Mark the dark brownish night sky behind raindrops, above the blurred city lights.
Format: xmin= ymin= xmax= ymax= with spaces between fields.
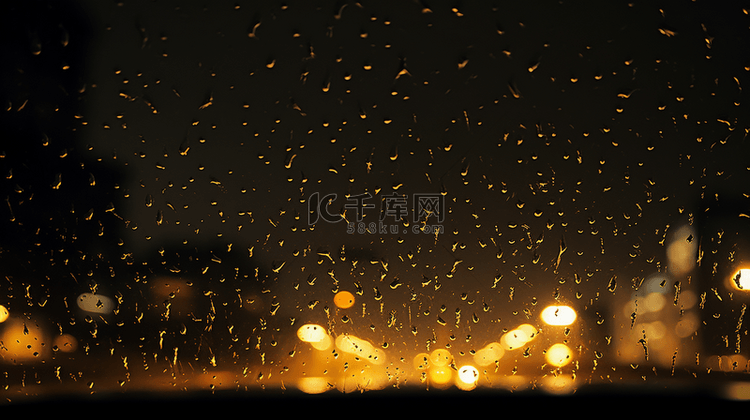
xmin=72 ymin=2 xmax=747 ymax=298
